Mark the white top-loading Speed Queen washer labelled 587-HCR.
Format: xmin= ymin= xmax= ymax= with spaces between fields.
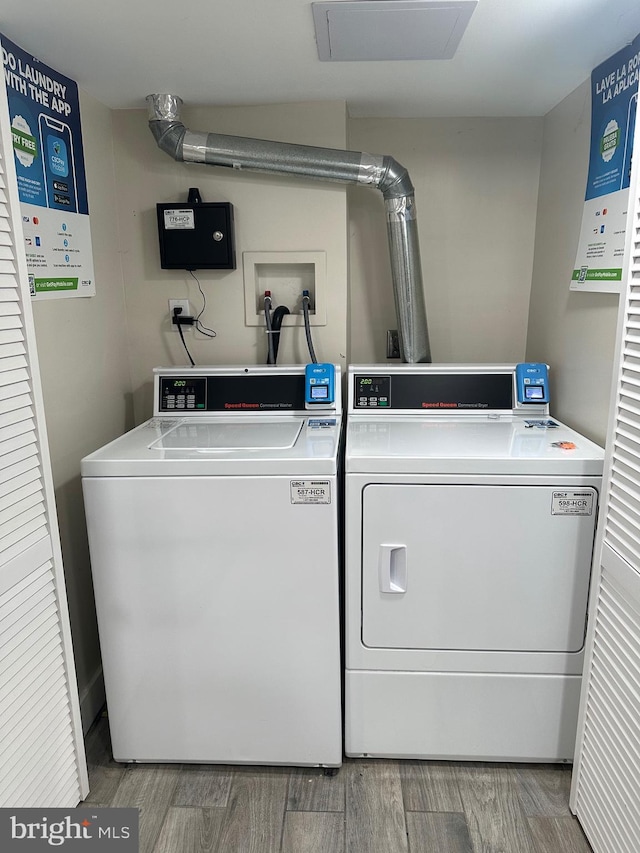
xmin=82 ymin=366 xmax=342 ymax=767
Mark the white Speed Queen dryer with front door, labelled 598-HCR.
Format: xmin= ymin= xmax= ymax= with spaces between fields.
xmin=345 ymin=365 xmax=603 ymax=761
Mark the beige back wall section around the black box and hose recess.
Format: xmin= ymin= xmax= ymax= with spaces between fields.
xmin=113 ymin=102 xmax=347 ymax=421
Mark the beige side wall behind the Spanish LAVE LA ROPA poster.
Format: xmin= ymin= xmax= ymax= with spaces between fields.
xmin=527 ymin=81 xmax=618 ymax=444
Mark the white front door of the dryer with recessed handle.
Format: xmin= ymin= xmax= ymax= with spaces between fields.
xmin=362 ymin=484 xmax=597 ymax=652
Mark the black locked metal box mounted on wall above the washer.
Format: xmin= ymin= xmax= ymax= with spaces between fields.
xmin=156 ymin=202 xmax=236 ymax=270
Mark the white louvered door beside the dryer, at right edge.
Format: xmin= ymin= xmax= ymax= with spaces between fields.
xmin=571 ymin=103 xmax=640 ymax=853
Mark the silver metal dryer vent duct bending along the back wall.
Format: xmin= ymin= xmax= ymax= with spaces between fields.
xmin=147 ymin=95 xmax=431 ymax=363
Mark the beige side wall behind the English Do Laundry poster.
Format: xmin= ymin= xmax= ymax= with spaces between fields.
xmin=33 ymin=88 xmax=132 ymax=725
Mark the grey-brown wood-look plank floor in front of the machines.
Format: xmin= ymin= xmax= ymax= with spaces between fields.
xmin=84 ymin=717 xmax=591 ymax=853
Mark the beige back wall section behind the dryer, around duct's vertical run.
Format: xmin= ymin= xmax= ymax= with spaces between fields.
xmin=349 ymin=118 xmax=542 ymax=363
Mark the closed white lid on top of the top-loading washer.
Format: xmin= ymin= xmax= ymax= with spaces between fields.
xmin=149 ymin=418 xmax=304 ymax=453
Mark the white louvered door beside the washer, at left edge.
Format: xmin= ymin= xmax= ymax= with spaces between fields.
xmin=0 ymin=70 xmax=88 ymax=808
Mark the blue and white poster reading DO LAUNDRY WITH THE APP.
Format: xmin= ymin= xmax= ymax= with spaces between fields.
xmin=0 ymin=35 xmax=96 ymax=299
